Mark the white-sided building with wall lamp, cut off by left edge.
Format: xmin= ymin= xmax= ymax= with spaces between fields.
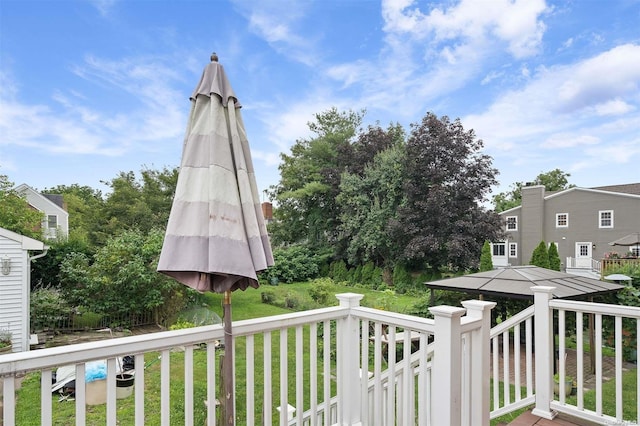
xmin=0 ymin=228 xmax=48 ymax=352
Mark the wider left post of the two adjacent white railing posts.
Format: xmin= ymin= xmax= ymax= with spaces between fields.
xmin=429 ymin=306 xmax=466 ymax=426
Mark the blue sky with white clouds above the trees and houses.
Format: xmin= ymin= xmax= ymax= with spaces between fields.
xmin=0 ymin=0 xmax=640 ymax=201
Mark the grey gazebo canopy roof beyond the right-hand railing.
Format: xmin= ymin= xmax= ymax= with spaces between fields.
xmin=426 ymin=265 xmax=624 ymax=299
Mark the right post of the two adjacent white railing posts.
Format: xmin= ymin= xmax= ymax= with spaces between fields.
xmin=462 ymin=300 xmax=496 ymax=426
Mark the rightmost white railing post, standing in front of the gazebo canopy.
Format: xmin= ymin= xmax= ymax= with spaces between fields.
xmin=531 ymin=286 xmax=557 ymax=420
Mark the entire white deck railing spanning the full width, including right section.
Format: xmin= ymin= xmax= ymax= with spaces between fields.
xmin=0 ymin=292 xmax=640 ymax=426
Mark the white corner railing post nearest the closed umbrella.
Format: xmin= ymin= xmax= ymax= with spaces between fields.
xmin=336 ymin=293 xmax=364 ymax=425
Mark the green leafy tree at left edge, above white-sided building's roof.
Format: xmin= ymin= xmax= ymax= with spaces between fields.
xmin=0 ymin=174 xmax=44 ymax=240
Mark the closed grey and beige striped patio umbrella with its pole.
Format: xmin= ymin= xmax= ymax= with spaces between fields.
xmin=158 ymin=53 xmax=273 ymax=424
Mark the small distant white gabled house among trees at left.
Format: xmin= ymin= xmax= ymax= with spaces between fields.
xmin=15 ymin=183 xmax=69 ymax=239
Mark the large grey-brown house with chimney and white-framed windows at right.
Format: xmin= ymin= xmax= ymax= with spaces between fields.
xmin=492 ymin=183 xmax=640 ymax=272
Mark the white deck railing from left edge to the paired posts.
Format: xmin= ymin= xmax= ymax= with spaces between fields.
xmin=0 ymin=294 xmax=493 ymax=426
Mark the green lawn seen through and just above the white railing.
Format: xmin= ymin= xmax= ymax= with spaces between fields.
xmin=16 ymin=282 xmax=416 ymax=426
